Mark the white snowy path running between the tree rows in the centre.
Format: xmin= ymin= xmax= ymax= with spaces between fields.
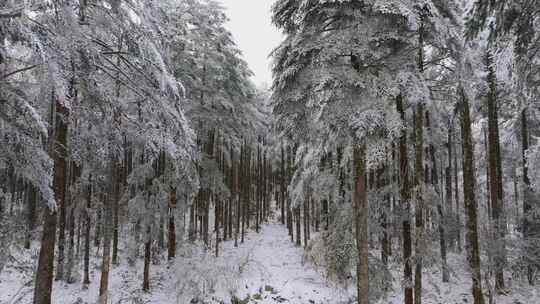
xmin=229 ymin=223 xmax=349 ymax=304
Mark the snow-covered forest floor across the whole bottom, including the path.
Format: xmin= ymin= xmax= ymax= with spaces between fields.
xmin=0 ymin=224 xmax=540 ymax=304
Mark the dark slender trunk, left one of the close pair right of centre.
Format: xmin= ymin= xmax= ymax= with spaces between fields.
xmin=396 ymin=95 xmax=413 ymax=304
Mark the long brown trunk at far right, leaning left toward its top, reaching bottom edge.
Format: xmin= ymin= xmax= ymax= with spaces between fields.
xmin=459 ymin=86 xmax=485 ymax=304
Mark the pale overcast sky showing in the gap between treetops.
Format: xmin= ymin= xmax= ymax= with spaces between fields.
xmin=219 ymin=0 xmax=282 ymax=85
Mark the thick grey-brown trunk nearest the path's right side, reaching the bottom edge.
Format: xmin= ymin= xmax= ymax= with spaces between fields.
xmin=353 ymin=143 xmax=369 ymax=304
